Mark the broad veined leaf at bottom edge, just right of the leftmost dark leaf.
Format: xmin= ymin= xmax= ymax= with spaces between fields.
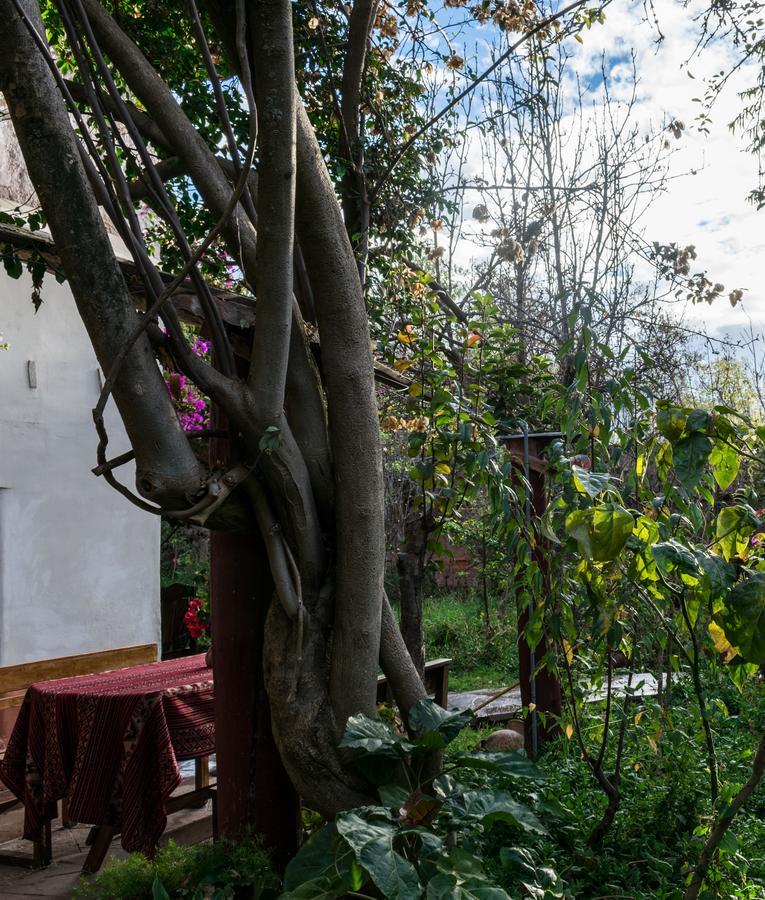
xmin=336 ymin=807 xmax=422 ymax=900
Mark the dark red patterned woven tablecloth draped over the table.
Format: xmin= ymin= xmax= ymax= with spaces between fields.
xmin=0 ymin=654 xmax=215 ymax=852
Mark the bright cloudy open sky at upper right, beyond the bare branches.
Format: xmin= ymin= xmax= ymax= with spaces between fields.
xmin=442 ymin=0 xmax=765 ymax=337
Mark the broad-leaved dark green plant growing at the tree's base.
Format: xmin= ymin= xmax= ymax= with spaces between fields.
xmin=282 ymin=700 xmax=545 ymax=900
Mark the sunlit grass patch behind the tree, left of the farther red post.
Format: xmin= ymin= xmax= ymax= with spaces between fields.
xmin=423 ymin=592 xmax=518 ymax=691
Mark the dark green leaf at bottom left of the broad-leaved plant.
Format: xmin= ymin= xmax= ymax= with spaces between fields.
xmin=284 ymin=822 xmax=361 ymax=900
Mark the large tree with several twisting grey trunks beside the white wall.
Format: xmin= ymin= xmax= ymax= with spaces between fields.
xmin=0 ymin=0 xmax=592 ymax=828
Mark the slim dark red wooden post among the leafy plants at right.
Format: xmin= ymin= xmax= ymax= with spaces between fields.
xmin=508 ymin=435 xmax=562 ymax=749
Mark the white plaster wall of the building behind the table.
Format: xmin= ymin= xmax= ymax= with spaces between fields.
xmin=0 ymin=268 xmax=160 ymax=665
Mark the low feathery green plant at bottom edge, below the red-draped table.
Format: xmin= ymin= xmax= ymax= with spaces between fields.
xmin=74 ymin=838 xmax=279 ymax=900
